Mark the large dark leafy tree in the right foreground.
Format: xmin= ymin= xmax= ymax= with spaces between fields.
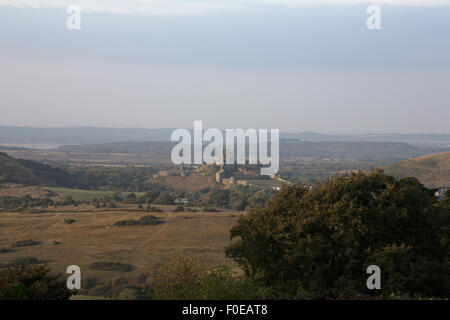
xmin=226 ymin=170 xmax=450 ymax=298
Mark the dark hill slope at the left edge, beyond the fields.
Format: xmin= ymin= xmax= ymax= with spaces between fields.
xmin=0 ymin=153 xmax=75 ymax=187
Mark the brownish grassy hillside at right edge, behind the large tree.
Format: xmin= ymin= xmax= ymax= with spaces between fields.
xmin=384 ymin=152 xmax=450 ymax=188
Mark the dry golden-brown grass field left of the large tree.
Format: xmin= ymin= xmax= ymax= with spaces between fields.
xmin=0 ymin=206 xmax=242 ymax=290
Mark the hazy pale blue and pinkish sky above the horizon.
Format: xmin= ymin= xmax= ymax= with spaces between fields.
xmin=0 ymin=0 xmax=450 ymax=133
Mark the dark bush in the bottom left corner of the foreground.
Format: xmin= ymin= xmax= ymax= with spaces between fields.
xmin=0 ymin=265 xmax=74 ymax=300
